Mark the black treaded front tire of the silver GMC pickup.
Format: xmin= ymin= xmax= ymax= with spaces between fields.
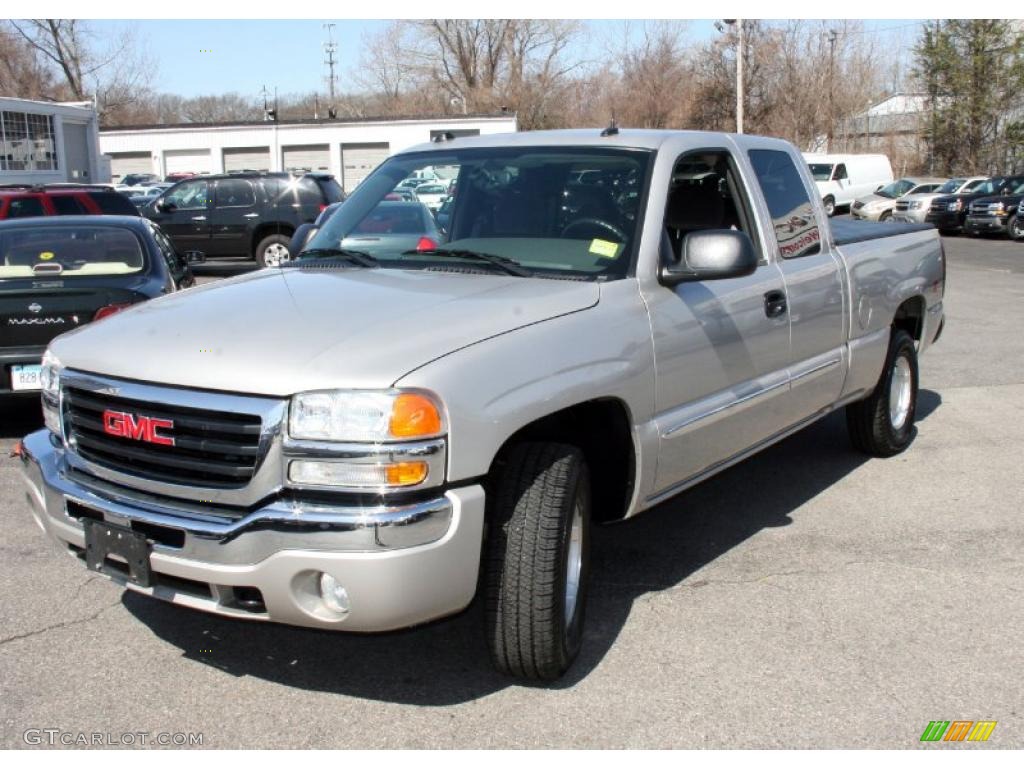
xmin=484 ymin=442 xmax=591 ymax=680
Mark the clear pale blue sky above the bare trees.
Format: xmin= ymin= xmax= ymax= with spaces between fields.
xmin=91 ymin=19 xmax=929 ymax=97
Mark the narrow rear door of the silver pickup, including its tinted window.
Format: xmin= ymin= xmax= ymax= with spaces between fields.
xmin=748 ymin=145 xmax=848 ymax=424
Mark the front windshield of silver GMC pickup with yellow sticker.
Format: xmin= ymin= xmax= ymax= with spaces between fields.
xmin=298 ymin=146 xmax=653 ymax=280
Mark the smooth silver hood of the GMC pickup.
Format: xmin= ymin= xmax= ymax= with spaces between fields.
xmin=50 ymin=267 xmax=600 ymax=396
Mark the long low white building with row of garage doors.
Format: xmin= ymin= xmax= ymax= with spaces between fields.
xmin=99 ymin=114 xmax=516 ymax=193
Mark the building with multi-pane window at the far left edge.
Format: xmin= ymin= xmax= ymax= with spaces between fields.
xmin=0 ymin=97 xmax=109 ymax=184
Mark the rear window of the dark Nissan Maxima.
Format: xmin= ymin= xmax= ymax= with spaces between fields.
xmin=0 ymin=226 xmax=144 ymax=279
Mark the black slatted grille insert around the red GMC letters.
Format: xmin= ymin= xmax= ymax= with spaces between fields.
xmin=62 ymin=386 xmax=262 ymax=488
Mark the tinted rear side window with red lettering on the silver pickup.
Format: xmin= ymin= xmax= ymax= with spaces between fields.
xmin=750 ymin=150 xmax=821 ymax=259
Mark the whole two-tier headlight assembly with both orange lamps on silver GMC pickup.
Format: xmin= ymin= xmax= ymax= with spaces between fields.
xmin=284 ymin=390 xmax=447 ymax=494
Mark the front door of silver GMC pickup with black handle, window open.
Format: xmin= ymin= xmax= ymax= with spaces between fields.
xmin=645 ymin=148 xmax=790 ymax=493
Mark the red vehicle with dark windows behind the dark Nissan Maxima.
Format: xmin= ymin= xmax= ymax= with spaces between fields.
xmin=0 ymin=184 xmax=138 ymax=220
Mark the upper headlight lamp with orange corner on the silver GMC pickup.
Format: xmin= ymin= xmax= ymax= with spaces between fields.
xmin=288 ymin=390 xmax=444 ymax=442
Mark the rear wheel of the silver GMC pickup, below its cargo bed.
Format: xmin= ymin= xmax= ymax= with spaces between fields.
xmin=846 ymin=329 xmax=918 ymax=457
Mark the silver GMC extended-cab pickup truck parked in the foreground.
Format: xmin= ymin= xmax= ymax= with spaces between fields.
xmin=16 ymin=128 xmax=945 ymax=680
